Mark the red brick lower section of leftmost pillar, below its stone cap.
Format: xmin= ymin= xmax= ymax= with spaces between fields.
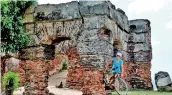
xmin=22 ymin=60 xmax=49 ymax=95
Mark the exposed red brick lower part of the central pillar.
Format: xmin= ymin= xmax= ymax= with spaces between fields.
xmin=66 ymin=48 xmax=106 ymax=95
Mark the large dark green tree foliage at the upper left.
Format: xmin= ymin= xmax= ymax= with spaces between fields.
xmin=0 ymin=0 xmax=37 ymax=53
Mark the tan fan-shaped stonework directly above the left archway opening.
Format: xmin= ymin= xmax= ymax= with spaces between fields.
xmin=35 ymin=20 xmax=82 ymax=44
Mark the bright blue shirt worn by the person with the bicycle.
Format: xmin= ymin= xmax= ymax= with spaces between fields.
xmin=112 ymin=57 xmax=123 ymax=73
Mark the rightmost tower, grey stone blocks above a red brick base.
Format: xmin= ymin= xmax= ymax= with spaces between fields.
xmin=125 ymin=19 xmax=152 ymax=89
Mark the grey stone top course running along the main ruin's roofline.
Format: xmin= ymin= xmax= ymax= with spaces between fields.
xmin=29 ymin=0 xmax=129 ymax=31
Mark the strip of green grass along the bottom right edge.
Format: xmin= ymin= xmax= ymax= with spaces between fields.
xmin=112 ymin=91 xmax=172 ymax=95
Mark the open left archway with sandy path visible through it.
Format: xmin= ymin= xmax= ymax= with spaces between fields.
xmin=48 ymin=35 xmax=72 ymax=87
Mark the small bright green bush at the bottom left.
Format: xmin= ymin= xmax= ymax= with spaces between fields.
xmin=2 ymin=72 xmax=19 ymax=95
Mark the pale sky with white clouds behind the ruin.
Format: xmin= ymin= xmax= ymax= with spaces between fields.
xmin=38 ymin=0 xmax=172 ymax=88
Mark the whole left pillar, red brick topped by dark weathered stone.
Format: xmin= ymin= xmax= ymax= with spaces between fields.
xmin=20 ymin=45 xmax=55 ymax=95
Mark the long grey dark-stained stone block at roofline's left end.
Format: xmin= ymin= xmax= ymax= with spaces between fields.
xmin=34 ymin=1 xmax=81 ymax=21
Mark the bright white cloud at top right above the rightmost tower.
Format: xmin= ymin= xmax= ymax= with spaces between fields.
xmin=128 ymin=0 xmax=166 ymax=14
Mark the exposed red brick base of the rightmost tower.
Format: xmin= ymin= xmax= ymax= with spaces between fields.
xmin=124 ymin=62 xmax=152 ymax=89
